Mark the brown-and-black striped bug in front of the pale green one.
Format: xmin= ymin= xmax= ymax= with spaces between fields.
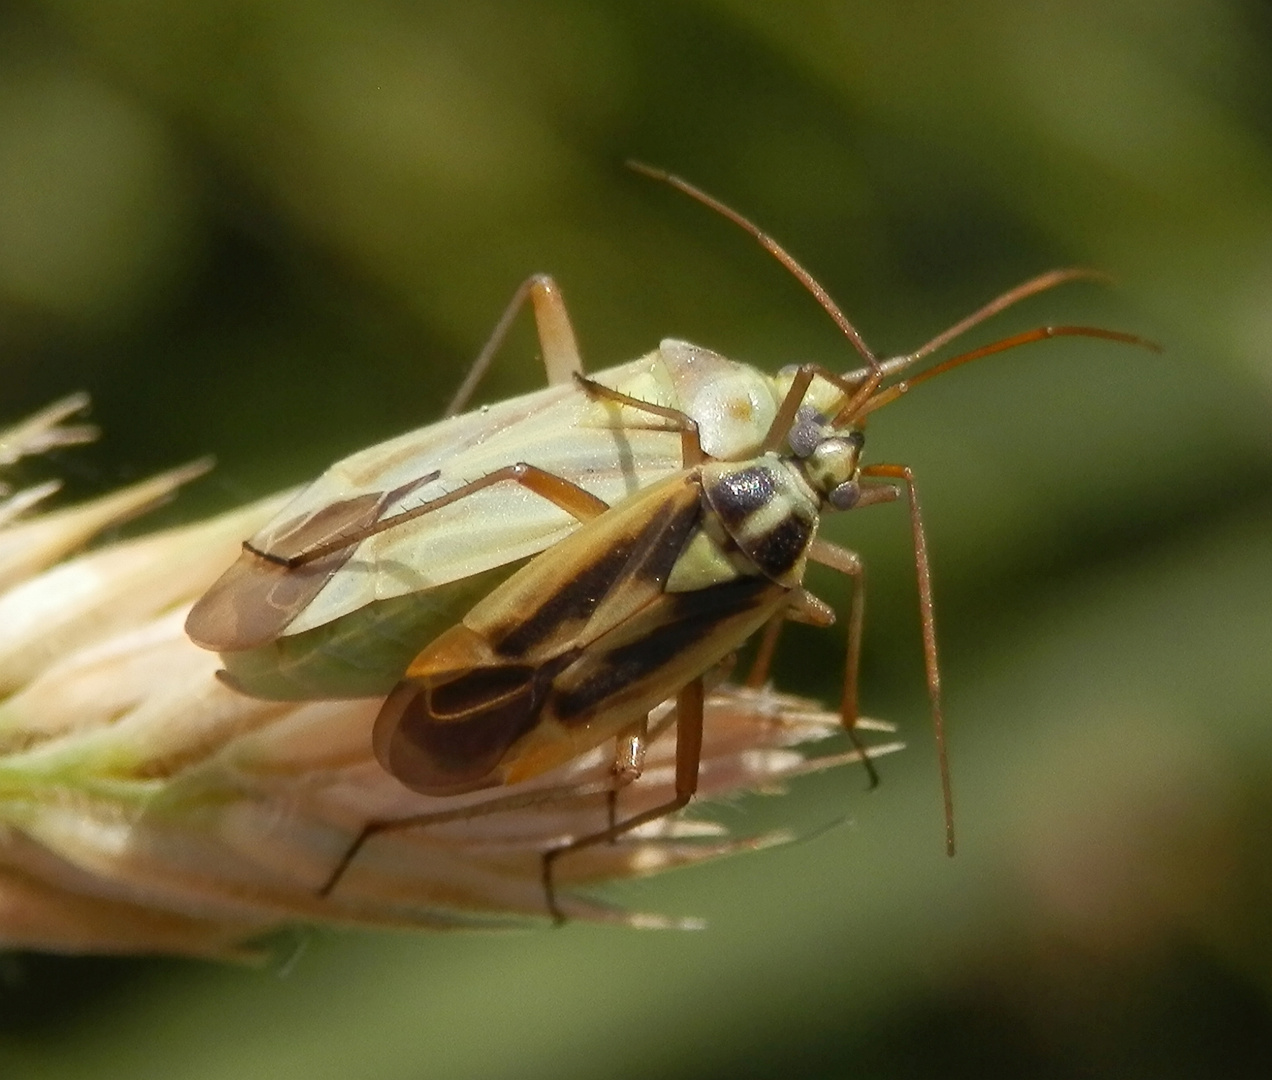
xmin=312 ymin=164 xmax=1147 ymax=921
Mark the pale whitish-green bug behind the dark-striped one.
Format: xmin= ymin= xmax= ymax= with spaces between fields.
xmin=186 ymin=286 xmax=803 ymax=698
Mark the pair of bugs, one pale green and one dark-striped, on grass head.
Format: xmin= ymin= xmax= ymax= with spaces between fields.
xmin=187 ymin=167 xmax=1147 ymax=920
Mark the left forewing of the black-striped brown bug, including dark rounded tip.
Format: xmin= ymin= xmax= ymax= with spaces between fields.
xmin=373 ymin=473 xmax=701 ymax=795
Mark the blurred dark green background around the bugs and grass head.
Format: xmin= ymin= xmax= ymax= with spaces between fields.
xmin=0 ymin=0 xmax=1272 ymax=1080
